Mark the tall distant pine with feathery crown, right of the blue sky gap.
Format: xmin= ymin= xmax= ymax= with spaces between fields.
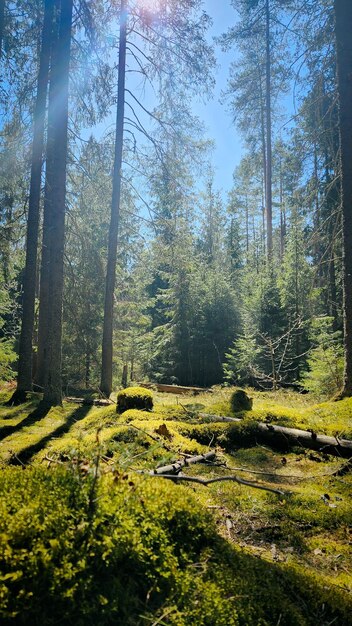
xmin=220 ymin=0 xmax=292 ymax=265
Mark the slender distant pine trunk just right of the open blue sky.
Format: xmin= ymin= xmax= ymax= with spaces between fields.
xmin=265 ymin=0 xmax=273 ymax=265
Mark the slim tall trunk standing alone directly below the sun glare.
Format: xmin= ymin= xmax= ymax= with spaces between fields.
xmin=100 ymin=0 xmax=127 ymax=396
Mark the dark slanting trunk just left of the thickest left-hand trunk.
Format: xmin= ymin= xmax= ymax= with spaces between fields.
xmin=14 ymin=0 xmax=54 ymax=401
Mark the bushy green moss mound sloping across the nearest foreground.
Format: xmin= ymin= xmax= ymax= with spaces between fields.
xmin=0 ymin=468 xmax=352 ymax=626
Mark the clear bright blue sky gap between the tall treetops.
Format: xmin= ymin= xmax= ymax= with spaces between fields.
xmin=193 ymin=0 xmax=242 ymax=197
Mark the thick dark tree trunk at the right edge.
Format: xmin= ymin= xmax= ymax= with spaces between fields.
xmin=334 ymin=0 xmax=352 ymax=396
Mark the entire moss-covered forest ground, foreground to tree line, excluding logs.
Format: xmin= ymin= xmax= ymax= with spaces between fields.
xmin=0 ymin=388 xmax=352 ymax=626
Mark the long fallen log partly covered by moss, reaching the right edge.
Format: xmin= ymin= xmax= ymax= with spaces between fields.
xmin=199 ymin=413 xmax=352 ymax=459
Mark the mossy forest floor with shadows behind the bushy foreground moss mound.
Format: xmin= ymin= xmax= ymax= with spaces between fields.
xmin=0 ymin=388 xmax=352 ymax=626
